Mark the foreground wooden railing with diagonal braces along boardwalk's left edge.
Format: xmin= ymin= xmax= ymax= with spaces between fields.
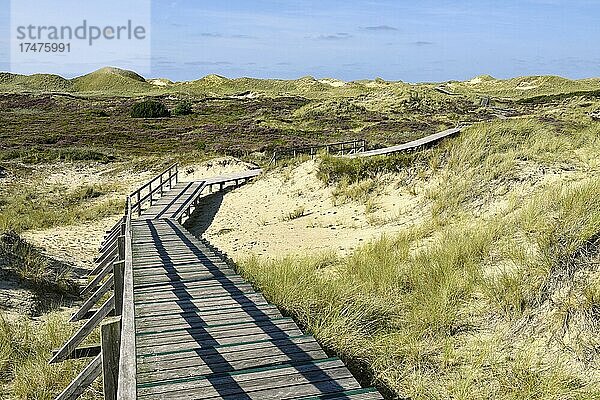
xmin=50 ymin=205 xmax=130 ymax=400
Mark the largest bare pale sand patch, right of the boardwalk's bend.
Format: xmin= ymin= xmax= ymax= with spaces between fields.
xmin=188 ymin=161 xmax=422 ymax=259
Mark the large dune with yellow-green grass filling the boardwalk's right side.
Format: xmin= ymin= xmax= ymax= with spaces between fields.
xmin=240 ymin=119 xmax=600 ymax=399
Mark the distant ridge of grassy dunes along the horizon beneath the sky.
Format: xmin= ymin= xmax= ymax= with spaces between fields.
xmin=0 ymin=67 xmax=600 ymax=100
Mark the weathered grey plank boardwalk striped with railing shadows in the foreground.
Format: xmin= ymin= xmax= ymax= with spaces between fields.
xmin=54 ymin=165 xmax=382 ymax=400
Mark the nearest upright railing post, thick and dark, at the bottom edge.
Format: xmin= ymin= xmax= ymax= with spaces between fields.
xmin=100 ymin=317 xmax=121 ymax=400
